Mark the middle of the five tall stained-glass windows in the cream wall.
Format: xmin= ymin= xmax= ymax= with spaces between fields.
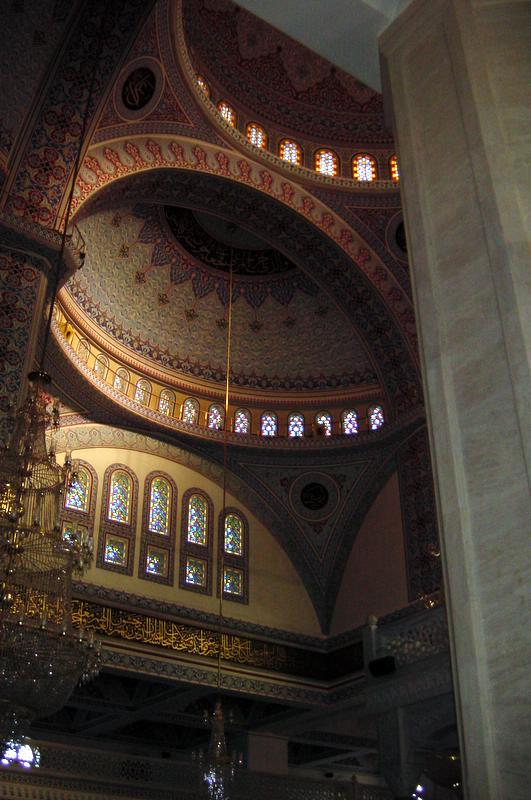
xmin=138 ymin=472 xmax=177 ymax=585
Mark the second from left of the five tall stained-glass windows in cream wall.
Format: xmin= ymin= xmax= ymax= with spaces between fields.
xmin=97 ymin=464 xmax=138 ymax=575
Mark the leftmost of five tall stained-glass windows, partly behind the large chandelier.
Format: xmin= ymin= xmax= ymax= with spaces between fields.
xmin=61 ymin=461 xmax=98 ymax=569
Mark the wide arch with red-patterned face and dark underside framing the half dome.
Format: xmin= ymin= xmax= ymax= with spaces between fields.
xmin=73 ymin=147 xmax=420 ymax=411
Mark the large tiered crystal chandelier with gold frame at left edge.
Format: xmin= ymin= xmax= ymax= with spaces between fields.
xmin=0 ymin=372 xmax=99 ymax=748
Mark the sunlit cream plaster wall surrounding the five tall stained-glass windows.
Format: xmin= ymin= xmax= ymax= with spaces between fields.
xmin=63 ymin=447 xmax=320 ymax=636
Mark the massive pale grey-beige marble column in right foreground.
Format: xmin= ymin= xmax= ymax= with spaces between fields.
xmin=380 ymin=0 xmax=531 ymax=800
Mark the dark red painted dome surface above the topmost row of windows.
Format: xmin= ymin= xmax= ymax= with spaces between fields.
xmin=183 ymin=0 xmax=392 ymax=145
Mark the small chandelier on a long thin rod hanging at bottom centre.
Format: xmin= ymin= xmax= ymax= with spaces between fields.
xmin=198 ymin=257 xmax=243 ymax=800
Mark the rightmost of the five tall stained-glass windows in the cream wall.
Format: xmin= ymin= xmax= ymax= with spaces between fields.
xmin=218 ymin=508 xmax=249 ymax=603
